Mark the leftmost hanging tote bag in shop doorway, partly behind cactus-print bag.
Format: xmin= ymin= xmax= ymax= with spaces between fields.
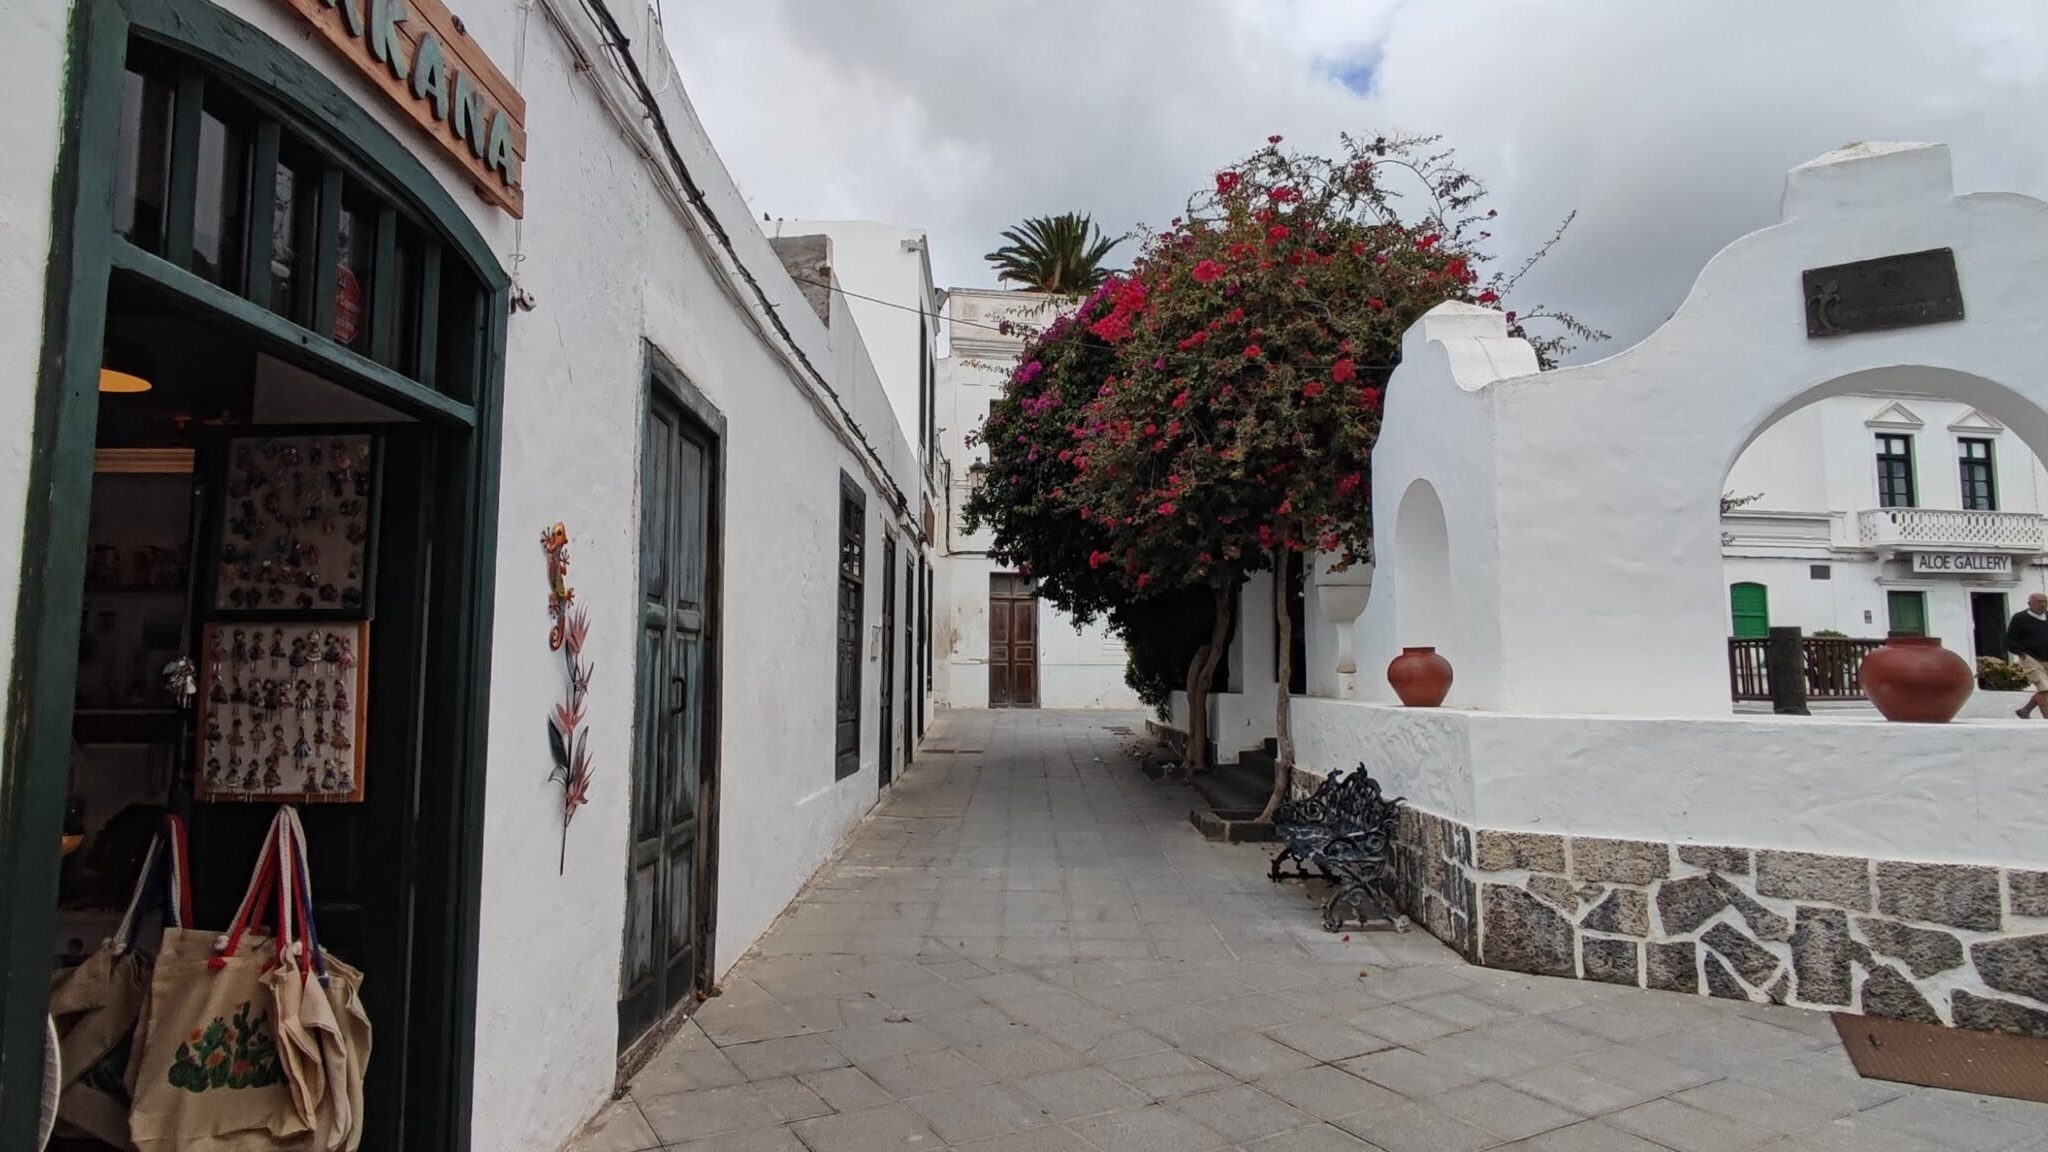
xmin=49 ymin=816 xmax=193 ymax=1150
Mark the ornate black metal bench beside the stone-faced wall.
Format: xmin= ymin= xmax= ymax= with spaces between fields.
xmin=1268 ymin=763 xmax=1407 ymax=933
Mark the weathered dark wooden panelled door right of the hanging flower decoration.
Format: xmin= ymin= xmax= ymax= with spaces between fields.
xmin=618 ymin=389 xmax=717 ymax=1052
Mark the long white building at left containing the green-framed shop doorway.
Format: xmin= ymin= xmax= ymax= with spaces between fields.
xmin=0 ymin=0 xmax=930 ymax=1152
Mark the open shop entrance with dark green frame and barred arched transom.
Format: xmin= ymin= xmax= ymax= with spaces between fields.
xmin=0 ymin=0 xmax=506 ymax=1150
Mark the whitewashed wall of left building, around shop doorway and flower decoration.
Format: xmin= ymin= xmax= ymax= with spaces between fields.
xmin=0 ymin=0 xmax=918 ymax=1152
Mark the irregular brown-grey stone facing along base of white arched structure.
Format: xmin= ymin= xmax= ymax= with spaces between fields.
xmin=1395 ymin=808 xmax=2048 ymax=1035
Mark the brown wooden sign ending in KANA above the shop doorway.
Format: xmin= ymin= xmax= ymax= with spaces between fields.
xmin=285 ymin=0 xmax=526 ymax=217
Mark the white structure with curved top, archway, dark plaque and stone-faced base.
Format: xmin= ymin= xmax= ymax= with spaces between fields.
xmin=1187 ymin=143 xmax=2048 ymax=1035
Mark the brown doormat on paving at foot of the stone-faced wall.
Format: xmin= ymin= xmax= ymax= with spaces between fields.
xmin=1833 ymin=1013 xmax=2048 ymax=1103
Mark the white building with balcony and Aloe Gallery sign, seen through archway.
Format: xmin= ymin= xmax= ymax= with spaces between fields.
xmin=1722 ymin=389 xmax=2048 ymax=658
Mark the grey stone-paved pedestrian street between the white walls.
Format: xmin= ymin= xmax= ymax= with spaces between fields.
xmin=573 ymin=711 xmax=2048 ymax=1152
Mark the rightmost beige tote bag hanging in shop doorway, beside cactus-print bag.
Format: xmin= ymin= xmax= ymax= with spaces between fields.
xmin=264 ymin=808 xmax=371 ymax=1152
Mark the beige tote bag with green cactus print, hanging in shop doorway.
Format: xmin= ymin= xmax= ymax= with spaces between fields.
xmin=129 ymin=814 xmax=311 ymax=1152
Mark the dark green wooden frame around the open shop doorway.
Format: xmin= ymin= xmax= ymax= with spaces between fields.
xmin=0 ymin=0 xmax=508 ymax=1150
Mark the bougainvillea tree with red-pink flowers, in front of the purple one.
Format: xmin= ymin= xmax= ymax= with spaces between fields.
xmin=1081 ymin=137 xmax=1597 ymax=816
